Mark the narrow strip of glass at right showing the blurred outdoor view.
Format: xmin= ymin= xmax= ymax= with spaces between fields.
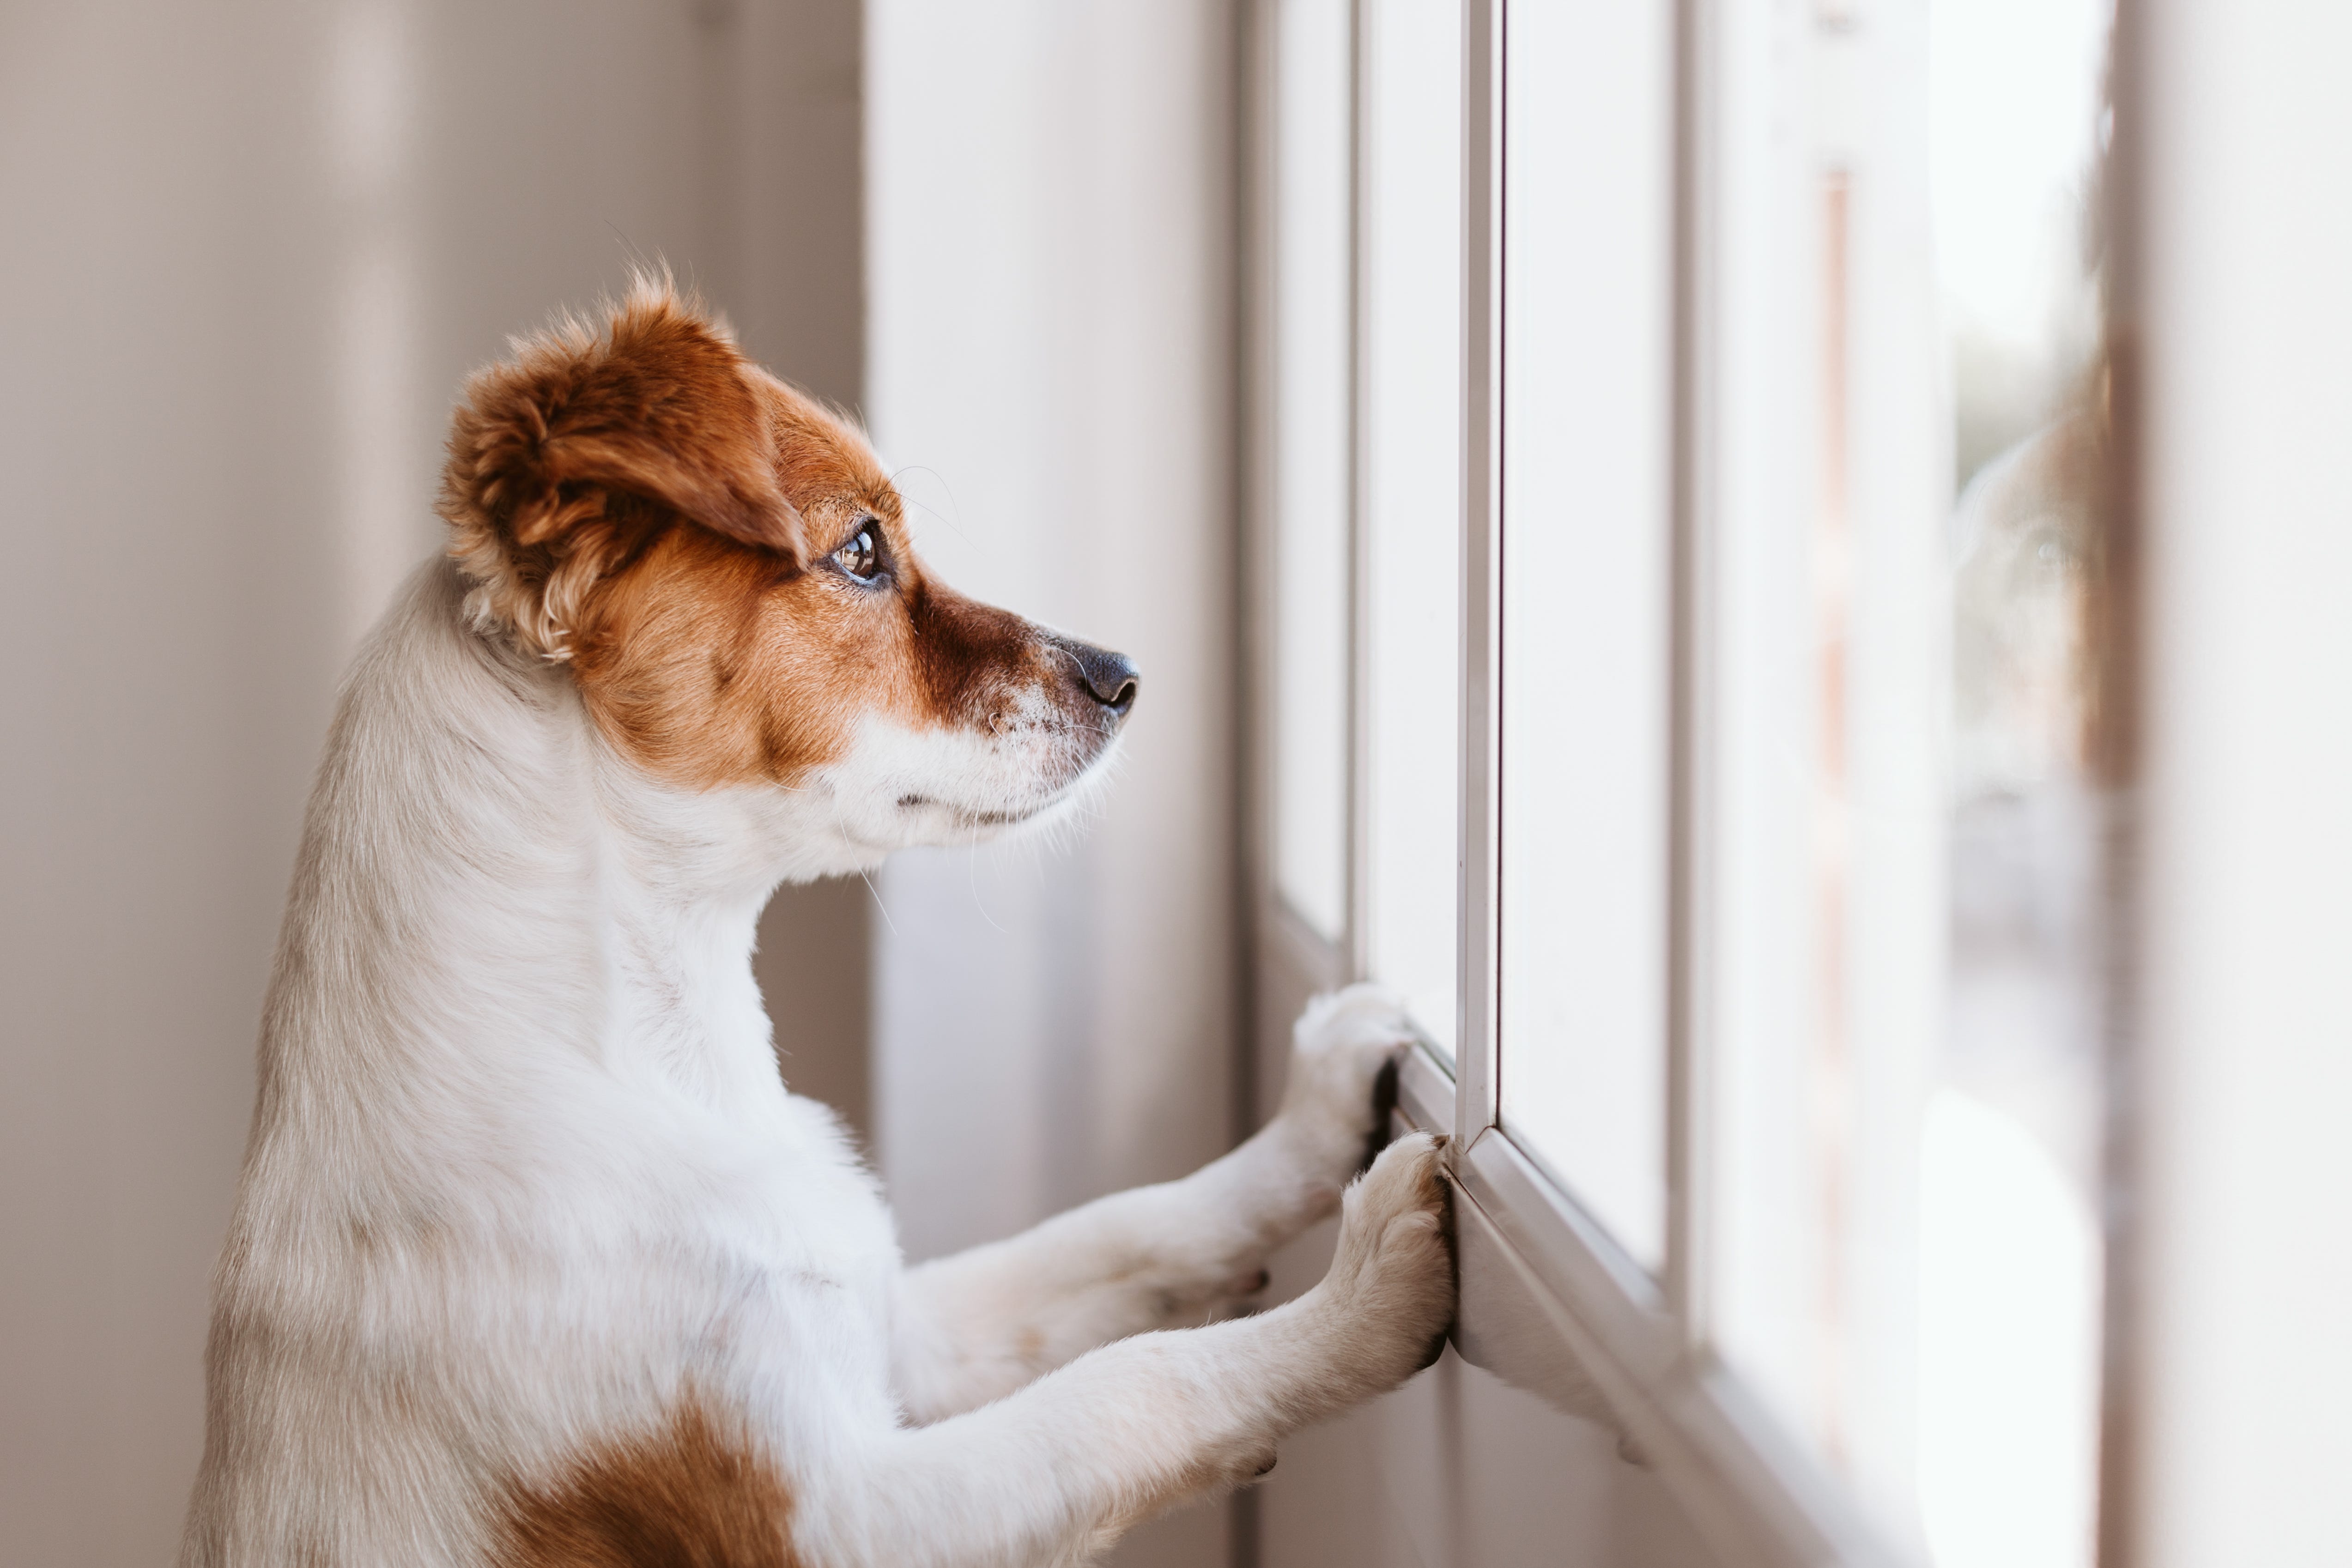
xmin=1919 ymin=0 xmax=2112 ymax=1568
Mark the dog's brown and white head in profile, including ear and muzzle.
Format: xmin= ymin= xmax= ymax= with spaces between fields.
xmin=442 ymin=282 xmax=1136 ymax=863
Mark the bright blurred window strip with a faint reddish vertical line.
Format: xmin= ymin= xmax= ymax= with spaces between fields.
xmin=1712 ymin=14 xmax=1950 ymax=1535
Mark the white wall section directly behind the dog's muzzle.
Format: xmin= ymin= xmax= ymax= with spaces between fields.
xmin=866 ymin=0 xmax=1239 ymax=1563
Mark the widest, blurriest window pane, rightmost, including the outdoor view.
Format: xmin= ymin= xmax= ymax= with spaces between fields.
xmin=1705 ymin=0 xmax=2107 ymax=1568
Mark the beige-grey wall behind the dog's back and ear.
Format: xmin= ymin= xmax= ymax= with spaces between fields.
xmin=0 ymin=0 xmax=863 ymax=1568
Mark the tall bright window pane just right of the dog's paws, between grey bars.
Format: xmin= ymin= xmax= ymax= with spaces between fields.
xmin=1498 ymin=0 xmax=1675 ymax=1267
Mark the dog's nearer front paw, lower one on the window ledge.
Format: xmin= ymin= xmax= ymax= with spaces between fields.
xmin=1308 ymin=1133 xmax=1454 ymax=1399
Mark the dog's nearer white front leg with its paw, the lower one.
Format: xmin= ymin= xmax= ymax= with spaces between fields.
xmin=813 ymin=1133 xmax=1454 ymax=1568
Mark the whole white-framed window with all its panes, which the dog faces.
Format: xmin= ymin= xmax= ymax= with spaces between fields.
xmin=1263 ymin=0 xmax=2110 ymax=1568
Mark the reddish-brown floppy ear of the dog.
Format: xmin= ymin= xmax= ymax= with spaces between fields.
xmin=440 ymin=278 xmax=807 ymax=658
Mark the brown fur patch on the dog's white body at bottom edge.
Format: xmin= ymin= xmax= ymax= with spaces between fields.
xmin=491 ymin=1396 xmax=795 ymax=1568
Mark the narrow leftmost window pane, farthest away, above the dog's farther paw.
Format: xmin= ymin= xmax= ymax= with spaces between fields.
xmin=1273 ymin=0 xmax=1352 ymax=940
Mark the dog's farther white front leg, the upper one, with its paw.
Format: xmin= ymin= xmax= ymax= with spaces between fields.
xmin=894 ymin=985 xmax=1409 ymax=1420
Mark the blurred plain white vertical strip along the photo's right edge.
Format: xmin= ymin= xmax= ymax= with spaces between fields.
xmin=2124 ymin=0 xmax=2352 ymax=1568
